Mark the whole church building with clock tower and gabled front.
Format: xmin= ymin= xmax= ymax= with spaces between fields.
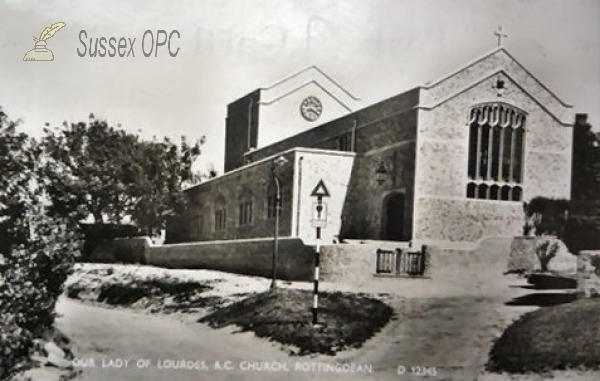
xmin=167 ymin=47 xmax=574 ymax=245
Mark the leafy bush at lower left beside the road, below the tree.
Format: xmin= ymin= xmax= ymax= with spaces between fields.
xmin=0 ymin=212 xmax=79 ymax=377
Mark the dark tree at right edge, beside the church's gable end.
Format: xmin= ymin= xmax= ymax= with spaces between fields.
xmin=571 ymin=114 xmax=600 ymax=200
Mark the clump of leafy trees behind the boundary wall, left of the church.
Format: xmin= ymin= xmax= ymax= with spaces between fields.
xmin=43 ymin=115 xmax=204 ymax=235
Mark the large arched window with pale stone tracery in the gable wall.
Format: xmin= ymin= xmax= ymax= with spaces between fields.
xmin=466 ymin=103 xmax=525 ymax=201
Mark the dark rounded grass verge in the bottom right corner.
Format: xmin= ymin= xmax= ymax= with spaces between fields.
xmin=486 ymin=299 xmax=600 ymax=373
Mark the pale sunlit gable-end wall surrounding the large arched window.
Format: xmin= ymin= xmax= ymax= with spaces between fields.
xmin=414 ymin=50 xmax=572 ymax=242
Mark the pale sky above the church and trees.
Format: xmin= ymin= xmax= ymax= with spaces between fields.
xmin=0 ymin=0 xmax=600 ymax=173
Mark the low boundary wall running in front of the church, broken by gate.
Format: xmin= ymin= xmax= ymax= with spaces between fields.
xmin=79 ymin=237 xmax=536 ymax=284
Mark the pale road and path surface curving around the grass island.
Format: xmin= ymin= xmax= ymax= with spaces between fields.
xmin=59 ymin=265 xmax=598 ymax=381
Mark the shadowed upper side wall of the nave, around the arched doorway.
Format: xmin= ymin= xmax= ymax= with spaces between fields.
xmin=248 ymin=88 xmax=420 ymax=240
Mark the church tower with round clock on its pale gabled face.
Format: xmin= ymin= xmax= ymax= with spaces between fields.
xmin=225 ymin=66 xmax=359 ymax=172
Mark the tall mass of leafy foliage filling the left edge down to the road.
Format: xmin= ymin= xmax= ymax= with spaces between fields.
xmin=0 ymin=108 xmax=78 ymax=379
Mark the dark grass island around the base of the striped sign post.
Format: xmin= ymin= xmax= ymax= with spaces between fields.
xmin=199 ymin=289 xmax=392 ymax=355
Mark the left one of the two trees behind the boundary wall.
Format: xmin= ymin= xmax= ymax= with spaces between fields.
xmin=42 ymin=115 xmax=139 ymax=223
